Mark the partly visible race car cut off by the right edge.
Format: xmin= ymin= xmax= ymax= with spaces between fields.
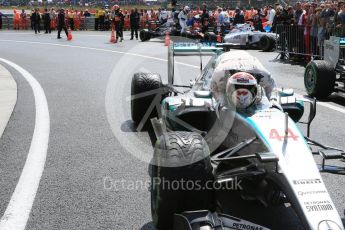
xmin=304 ymin=36 xmax=345 ymax=99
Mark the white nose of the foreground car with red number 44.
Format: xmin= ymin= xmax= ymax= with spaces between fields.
xmin=242 ymin=108 xmax=344 ymax=230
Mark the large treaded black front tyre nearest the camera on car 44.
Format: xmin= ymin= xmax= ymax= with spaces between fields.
xmin=151 ymin=131 xmax=214 ymax=230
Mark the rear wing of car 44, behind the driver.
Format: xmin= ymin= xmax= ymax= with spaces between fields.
xmin=168 ymin=42 xmax=233 ymax=85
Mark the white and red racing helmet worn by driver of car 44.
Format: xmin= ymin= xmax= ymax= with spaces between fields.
xmin=226 ymin=72 xmax=258 ymax=109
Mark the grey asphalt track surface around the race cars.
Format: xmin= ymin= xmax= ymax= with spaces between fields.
xmin=0 ymin=31 xmax=345 ymax=229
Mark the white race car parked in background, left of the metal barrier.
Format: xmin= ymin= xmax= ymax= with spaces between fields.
xmin=223 ymin=24 xmax=277 ymax=51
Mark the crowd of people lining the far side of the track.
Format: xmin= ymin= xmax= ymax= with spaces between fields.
xmin=0 ymin=1 xmax=345 ymax=51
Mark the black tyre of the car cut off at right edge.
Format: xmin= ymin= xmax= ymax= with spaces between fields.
xmin=304 ymin=60 xmax=336 ymax=99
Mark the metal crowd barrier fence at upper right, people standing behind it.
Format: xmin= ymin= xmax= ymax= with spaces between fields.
xmin=275 ymin=25 xmax=345 ymax=60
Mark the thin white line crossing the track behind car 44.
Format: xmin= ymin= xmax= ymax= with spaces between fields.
xmin=0 ymin=39 xmax=345 ymax=114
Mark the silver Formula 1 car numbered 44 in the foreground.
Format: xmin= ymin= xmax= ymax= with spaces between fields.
xmin=131 ymin=43 xmax=344 ymax=230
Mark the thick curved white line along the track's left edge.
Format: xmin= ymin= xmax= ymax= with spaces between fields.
xmin=0 ymin=58 xmax=50 ymax=230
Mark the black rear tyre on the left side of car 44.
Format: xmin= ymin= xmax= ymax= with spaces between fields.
xmin=131 ymin=73 xmax=162 ymax=127
